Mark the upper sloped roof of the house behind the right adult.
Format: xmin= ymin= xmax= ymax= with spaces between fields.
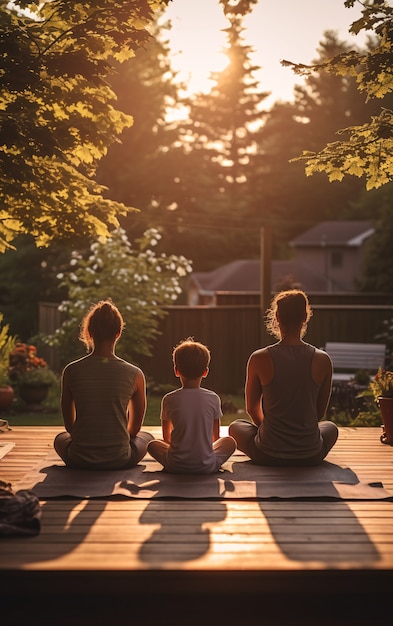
xmin=290 ymin=220 xmax=374 ymax=247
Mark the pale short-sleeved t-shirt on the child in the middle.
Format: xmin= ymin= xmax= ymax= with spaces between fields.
xmin=161 ymin=387 xmax=222 ymax=474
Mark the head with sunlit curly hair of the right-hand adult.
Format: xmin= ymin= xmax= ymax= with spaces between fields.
xmin=266 ymin=289 xmax=312 ymax=338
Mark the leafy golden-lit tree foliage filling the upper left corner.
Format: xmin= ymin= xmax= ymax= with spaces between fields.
xmin=0 ymin=0 xmax=169 ymax=251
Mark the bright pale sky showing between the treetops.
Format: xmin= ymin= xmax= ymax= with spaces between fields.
xmin=165 ymin=0 xmax=365 ymax=104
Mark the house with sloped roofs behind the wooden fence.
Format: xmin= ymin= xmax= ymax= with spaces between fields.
xmin=188 ymin=221 xmax=374 ymax=306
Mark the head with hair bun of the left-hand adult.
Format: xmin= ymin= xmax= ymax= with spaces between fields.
xmin=79 ymin=299 xmax=124 ymax=349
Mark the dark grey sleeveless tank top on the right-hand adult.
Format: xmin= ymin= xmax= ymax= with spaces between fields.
xmin=255 ymin=343 xmax=322 ymax=458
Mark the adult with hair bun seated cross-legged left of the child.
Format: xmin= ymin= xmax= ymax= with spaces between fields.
xmin=54 ymin=299 xmax=153 ymax=470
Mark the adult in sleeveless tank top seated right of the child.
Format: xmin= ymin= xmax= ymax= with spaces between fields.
xmin=229 ymin=289 xmax=338 ymax=465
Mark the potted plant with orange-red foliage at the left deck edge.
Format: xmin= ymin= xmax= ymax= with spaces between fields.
xmin=9 ymin=342 xmax=56 ymax=404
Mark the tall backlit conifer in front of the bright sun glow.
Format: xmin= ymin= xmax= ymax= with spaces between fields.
xmin=158 ymin=0 xmax=269 ymax=270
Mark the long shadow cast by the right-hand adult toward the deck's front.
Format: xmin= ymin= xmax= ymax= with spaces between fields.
xmin=233 ymin=461 xmax=380 ymax=566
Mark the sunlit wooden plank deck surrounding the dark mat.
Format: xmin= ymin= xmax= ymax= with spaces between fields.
xmin=0 ymin=426 xmax=393 ymax=626
